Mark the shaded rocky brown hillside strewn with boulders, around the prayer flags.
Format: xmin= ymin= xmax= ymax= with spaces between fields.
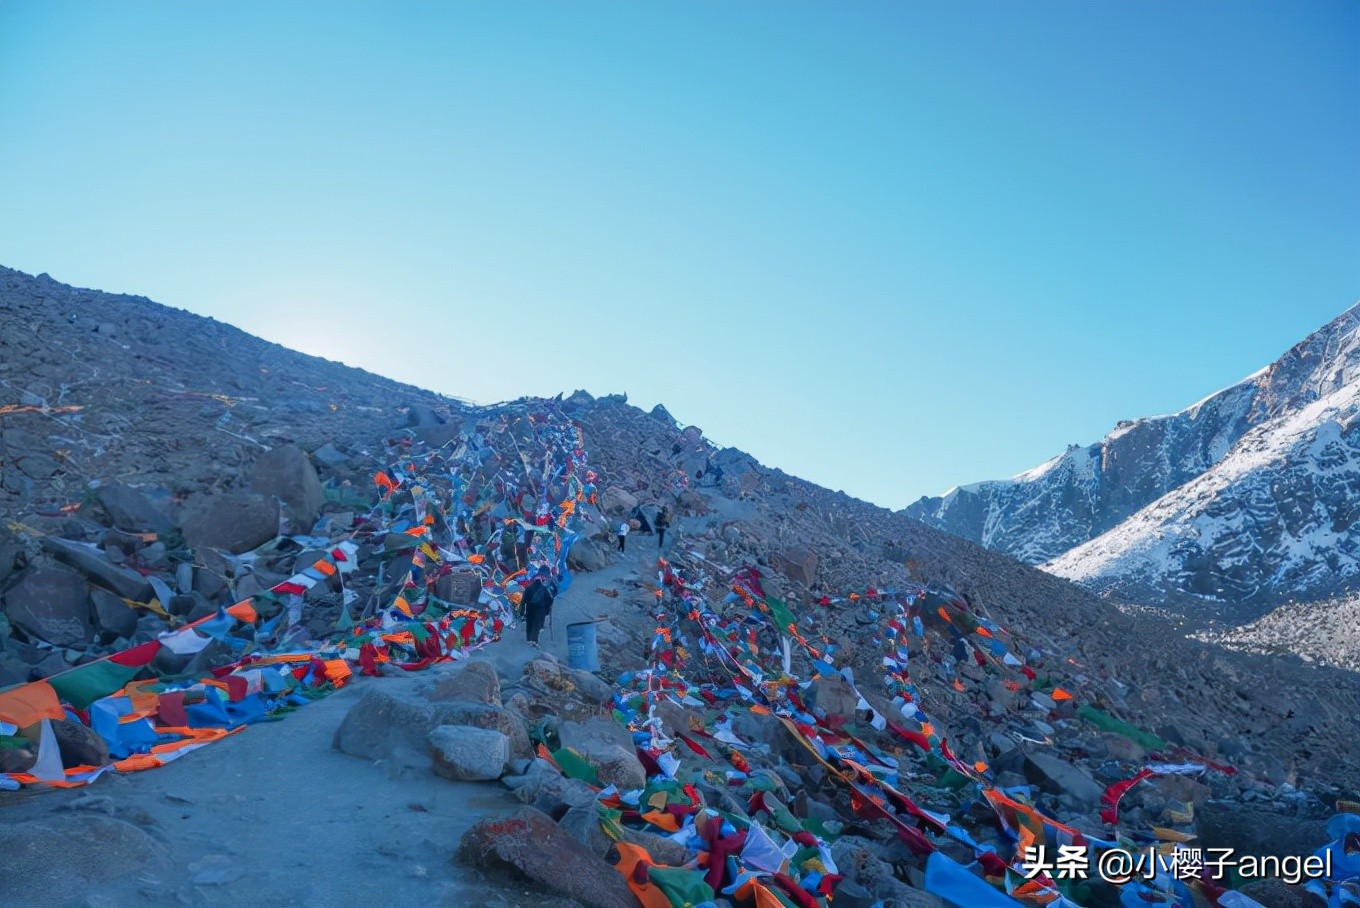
xmin=0 ymin=272 xmax=1360 ymax=904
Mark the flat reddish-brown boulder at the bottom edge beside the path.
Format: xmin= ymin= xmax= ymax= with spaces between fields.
xmin=456 ymin=807 xmax=638 ymax=908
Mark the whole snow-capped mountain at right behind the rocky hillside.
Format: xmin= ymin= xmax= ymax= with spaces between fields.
xmin=907 ymin=304 xmax=1360 ymax=608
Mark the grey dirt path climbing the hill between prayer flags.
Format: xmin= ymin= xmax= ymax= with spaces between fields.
xmin=0 ymin=500 xmax=728 ymax=908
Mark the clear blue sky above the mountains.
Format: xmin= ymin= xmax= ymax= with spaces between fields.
xmin=0 ymin=0 xmax=1360 ymax=507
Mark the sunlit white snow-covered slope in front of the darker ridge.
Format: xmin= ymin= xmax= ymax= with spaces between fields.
xmin=1044 ymin=372 xmax=1360 ymax=614
